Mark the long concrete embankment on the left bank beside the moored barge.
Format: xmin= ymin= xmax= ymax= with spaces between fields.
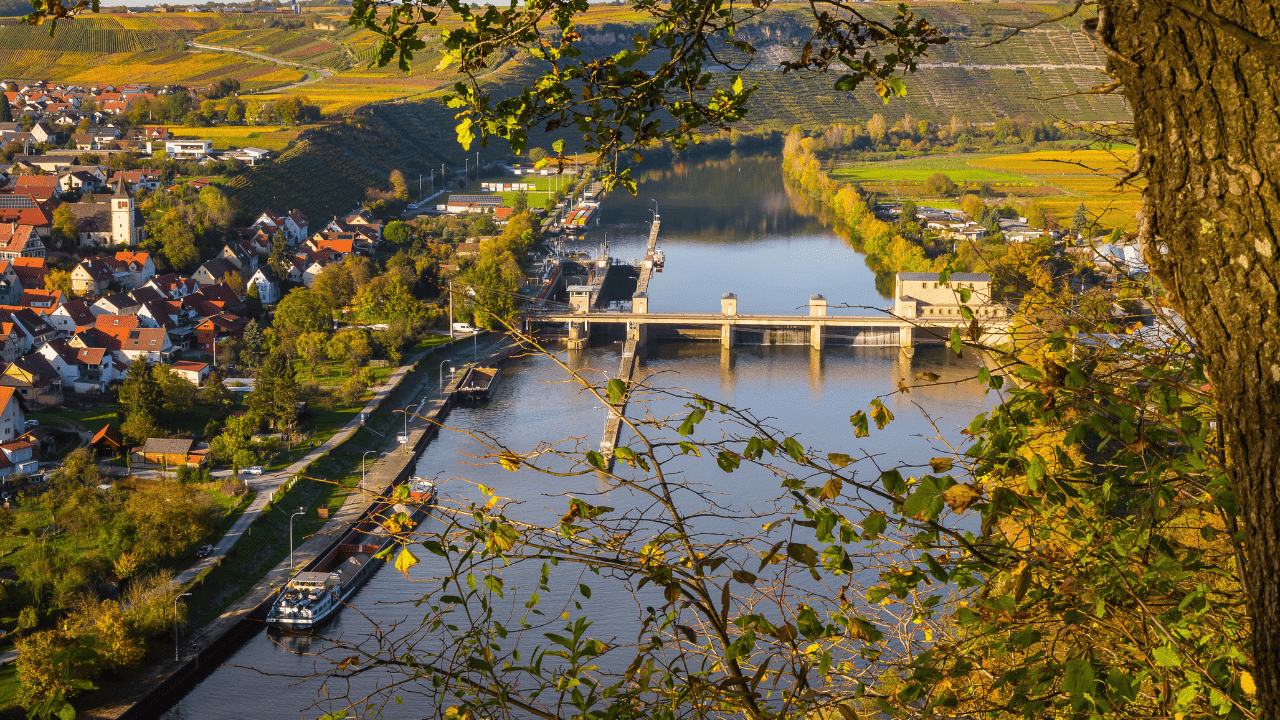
xmin=83 ymin=336 xmax=520 ymax=720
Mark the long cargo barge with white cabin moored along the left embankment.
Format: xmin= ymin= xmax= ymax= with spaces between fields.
xmin=266 ymin=503 xmax=425 ymax=630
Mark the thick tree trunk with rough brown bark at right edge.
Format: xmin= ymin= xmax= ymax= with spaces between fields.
xmin=1097 ymin=0 xmax=1280 ymax=707
